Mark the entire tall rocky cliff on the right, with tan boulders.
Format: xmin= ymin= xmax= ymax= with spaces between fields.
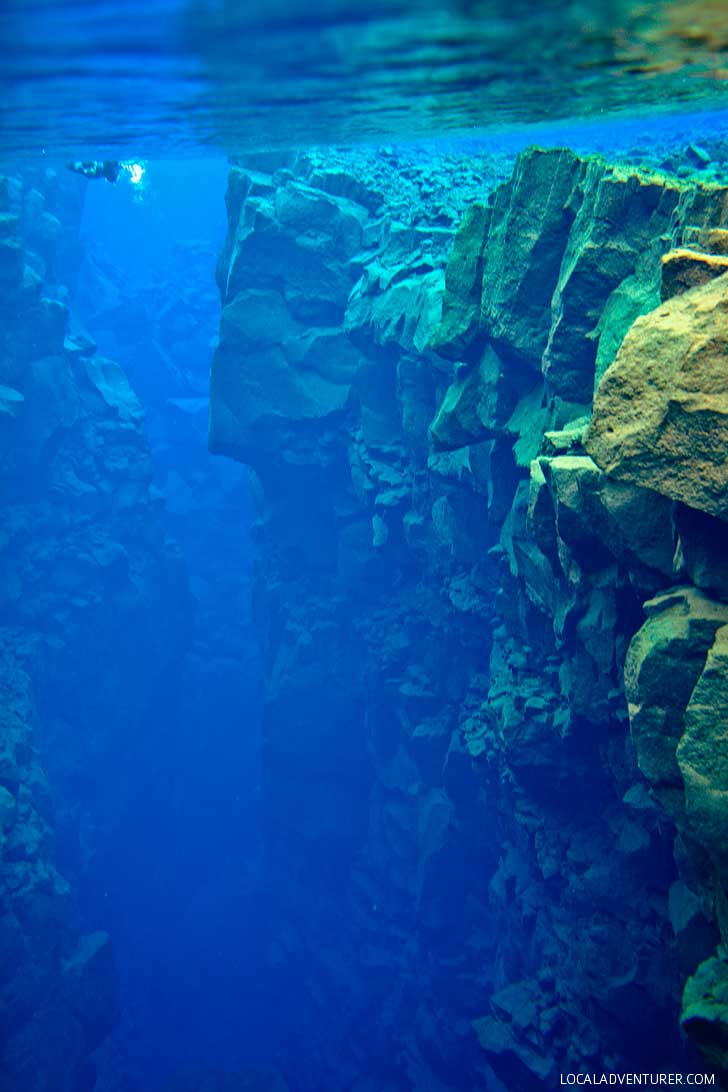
xmin=211 ymin=151 xmax=728 ymax=1092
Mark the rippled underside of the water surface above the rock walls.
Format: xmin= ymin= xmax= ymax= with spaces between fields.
xmin=0 ymin=0 xmax=728 ymax=157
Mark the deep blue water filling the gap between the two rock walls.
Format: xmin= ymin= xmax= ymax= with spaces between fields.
xmin=73 ymin=159 xmax=271 ymax=1087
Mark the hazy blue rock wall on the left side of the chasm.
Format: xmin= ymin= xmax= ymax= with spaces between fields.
xmin=0 ymin=165 xmax=187 ymax=1092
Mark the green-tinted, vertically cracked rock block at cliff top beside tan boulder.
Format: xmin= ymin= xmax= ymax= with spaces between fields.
xmin=432 ymin=150 xmax=690 ymax=405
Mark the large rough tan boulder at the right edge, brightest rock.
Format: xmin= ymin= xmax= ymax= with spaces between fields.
xmin=585 ymin=275 xmax=728 ymax=519
